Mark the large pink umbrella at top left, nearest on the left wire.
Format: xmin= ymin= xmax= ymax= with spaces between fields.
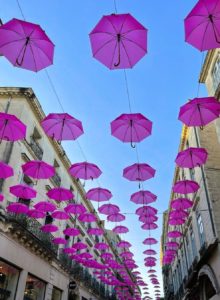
xmin=0 ymin=19 xmax=54 ymax=72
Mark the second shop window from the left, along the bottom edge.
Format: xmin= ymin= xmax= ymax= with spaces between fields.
xmin=23 ymin=274 xmax=46 ymax=300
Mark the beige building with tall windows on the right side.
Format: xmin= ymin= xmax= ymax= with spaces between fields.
xmin=162 ymin=50 xmax=220 ymax=300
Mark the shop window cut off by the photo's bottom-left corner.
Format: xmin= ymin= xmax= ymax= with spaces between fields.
xmin=0 ymin=259 xmax=19 ymax=300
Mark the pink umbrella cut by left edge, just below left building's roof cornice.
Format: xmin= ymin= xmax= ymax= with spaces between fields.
xmin=0 ymin=112 xmax=26 ymax=142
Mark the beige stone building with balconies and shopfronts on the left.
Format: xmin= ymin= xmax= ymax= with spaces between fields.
xmin=0 ymin=88 xmax=134 ymax=300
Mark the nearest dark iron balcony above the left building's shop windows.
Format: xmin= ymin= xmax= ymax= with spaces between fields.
xmin=6 ymin=213 xmax=58 ymax=257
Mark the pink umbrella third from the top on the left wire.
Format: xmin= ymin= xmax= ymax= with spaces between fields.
xmin=69 ymin=162 xmax=102 ymax=180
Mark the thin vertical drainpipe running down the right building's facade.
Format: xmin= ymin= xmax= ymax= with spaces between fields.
xmin=193 ymin=127 xmax=216 ymax=238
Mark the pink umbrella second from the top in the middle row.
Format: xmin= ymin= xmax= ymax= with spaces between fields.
xmin=111 ymin=113 xmax=152 ymax=147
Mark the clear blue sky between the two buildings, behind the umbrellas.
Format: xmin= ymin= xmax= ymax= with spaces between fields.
xmin=0 ymin=0 xmax=205 ymax=298
